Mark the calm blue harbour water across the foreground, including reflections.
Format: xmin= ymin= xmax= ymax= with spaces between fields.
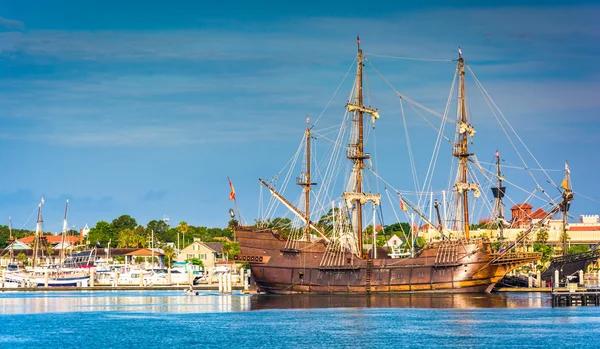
xmin=0 ymin=291 xmax=600 ymax=348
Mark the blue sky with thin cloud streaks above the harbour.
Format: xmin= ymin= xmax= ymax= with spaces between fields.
xmin=0 ymin=0 xmax=600 ymax=231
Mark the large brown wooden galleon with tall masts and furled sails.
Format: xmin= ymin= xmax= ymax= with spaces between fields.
xmin=234 ymin=38 xmax=573 ymax=294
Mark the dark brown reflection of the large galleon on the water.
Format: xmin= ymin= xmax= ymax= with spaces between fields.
xmin=250 ymin=293 xmax=550 ymax=310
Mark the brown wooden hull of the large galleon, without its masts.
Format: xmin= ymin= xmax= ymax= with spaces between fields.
xmin=235 ymin=227 xmax=541 ymax=294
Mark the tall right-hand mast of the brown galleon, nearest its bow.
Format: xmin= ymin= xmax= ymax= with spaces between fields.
xmin=452 ymin=47 xmax=479 ymax=239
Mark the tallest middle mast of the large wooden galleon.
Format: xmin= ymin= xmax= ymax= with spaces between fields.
xmin=343 ymin=36 xmax=380 ymax=256
